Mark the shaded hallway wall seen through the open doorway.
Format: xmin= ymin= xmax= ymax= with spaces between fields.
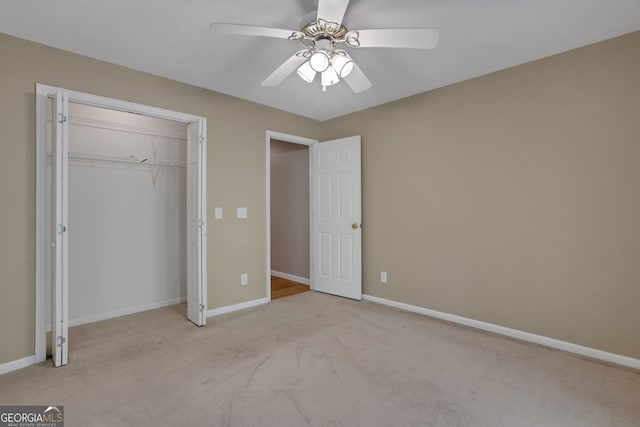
xmin=271 ymin=140 xmax=309 ymax=279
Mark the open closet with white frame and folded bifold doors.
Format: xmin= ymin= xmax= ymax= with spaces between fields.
xmin=35 ymin=84 xmax=207 ymax=366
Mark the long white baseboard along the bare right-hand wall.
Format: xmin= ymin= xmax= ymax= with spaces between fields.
xmin=362 ymin=295 xmax=640 ymax=369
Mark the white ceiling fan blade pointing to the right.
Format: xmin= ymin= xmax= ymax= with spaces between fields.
xmin=347 ymin=28 xmax=440 ymax=49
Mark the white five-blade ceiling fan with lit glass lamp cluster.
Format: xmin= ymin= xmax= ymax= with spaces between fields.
xmin=209 ymin=0 xmax=439 ymax=93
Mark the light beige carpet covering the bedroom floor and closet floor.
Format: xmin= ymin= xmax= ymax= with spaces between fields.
xmin=0 ymin=292 xmax=640 ymax=427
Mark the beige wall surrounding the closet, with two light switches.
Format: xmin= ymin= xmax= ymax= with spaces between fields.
xmin=0 ymin=34 xmax=320 ymax=363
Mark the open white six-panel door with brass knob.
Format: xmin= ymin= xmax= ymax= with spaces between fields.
xmin=310 ymin=136 xmax=362 ymax=300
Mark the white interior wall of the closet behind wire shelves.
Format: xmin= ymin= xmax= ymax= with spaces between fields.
xmin=47 ymin=103 xmax=187 ymax=326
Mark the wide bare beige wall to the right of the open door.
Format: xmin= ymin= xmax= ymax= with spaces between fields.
xmin=323 ymin=32 xmax=640 ymax=358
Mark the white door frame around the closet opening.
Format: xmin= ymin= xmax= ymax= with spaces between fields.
xmin=35 ymin=83 xmax=207 ymax=363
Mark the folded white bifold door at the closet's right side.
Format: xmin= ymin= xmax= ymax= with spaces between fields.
xmin=187 ymin=119 xmax=207 ymax=326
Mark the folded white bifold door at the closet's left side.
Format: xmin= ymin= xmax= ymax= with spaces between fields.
xmin=51 ymin=91 xmax=69 ymax=366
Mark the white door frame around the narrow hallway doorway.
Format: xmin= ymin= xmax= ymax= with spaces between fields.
xmin=265 ymin=130 xmax=319 ymax=301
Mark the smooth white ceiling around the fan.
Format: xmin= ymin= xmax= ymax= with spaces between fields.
xmin=0 ymin=0 xmax=640 ymax=120
